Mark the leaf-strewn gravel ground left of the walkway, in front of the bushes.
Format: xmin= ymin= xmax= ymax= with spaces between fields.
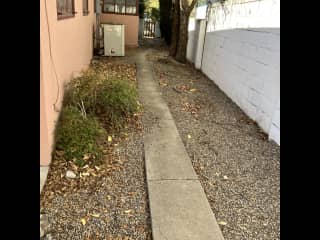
xmin=40 ymin=61 xmax=152 ymax=240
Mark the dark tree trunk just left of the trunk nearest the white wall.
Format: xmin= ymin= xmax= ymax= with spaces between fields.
xmin=169 ymin=0 xmax=180 ymax=57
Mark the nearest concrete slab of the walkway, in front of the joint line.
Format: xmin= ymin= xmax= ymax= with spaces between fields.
xmin=148 ymin=180 xmax=224 ymax=240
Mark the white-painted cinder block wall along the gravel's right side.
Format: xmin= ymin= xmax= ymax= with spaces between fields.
xmin=187 ymin=0 xmax=280 ymax=145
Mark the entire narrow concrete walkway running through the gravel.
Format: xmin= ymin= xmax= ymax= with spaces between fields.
xmin=136 ymin=51 xmax=223 ymax=240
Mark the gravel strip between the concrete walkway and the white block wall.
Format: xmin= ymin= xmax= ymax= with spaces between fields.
xmin=148 ymin=50 xmax=280 ymax=240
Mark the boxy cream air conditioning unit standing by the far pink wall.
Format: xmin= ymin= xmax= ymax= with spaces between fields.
xmin=102 ymin=24 xmax=124 ymax=56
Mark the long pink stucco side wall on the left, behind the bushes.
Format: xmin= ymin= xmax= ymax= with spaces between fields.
xmin=40 ymin=0 xmax=95 ymax=165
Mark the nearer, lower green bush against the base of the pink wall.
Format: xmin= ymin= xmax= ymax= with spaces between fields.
xmin=56 ymin=106 xmax=105 ymax=167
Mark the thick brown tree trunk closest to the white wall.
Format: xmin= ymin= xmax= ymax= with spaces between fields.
xmin=175 ymin=10 xmax=190 ymax=63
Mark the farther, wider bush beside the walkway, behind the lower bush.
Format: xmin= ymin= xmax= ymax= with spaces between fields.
xmin=65 ymin=71 xmax=138 ymax=129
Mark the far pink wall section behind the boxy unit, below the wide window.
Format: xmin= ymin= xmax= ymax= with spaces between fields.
xmin=101 ymin=13 xmax=139 ymax=47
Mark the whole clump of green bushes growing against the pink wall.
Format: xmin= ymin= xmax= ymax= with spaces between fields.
xmin=55 ymin=68 xmax=139 ymax=166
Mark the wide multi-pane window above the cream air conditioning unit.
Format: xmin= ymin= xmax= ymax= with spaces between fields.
xmin=102 ymin=0 xmax=138 ymax=15
